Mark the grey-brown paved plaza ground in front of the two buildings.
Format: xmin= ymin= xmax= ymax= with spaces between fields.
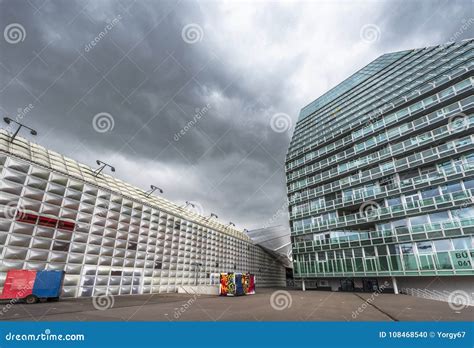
xmin=0 ymin=289 xmax=474 ymax=321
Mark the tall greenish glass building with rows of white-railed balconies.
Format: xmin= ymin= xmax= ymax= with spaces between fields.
xmin=286 ymin=40 xmax=474 ymax=297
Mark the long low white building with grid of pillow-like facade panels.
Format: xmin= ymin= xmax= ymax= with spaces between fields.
xmin=0 ymin=130 xmax=285 ymax=297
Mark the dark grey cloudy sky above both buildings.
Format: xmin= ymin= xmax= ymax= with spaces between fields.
xmin=0 ymin=0 xmax=474 ymax=229
